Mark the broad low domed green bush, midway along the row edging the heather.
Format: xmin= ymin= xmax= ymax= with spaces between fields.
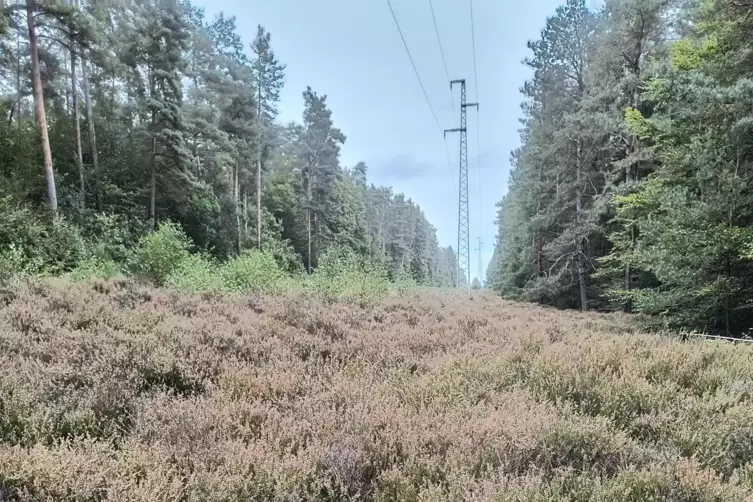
xmin=220 ymin=250 xmax=288 ymax=293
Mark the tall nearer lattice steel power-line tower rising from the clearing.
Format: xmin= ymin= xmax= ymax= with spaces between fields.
xmin=444 ymin=79 xmax=478 ymax=288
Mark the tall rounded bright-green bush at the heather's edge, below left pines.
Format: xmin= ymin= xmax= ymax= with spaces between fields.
xmin=130 ymin=221 xmax=191 ymax=286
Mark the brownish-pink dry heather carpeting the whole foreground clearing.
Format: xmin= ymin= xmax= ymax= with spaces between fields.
xmin=0 ymin=281 xmax=753 ymax=502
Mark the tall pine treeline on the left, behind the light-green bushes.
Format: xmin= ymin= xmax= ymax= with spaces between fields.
xmin=0 ymin=0 xmax=464 ymax=286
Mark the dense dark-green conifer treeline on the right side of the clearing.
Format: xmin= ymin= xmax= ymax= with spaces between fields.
xmin=488 ymin=0 xmax=753 ymax=333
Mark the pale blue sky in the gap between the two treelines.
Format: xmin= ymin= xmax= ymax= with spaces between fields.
xmin=196 ymin=0 xmax=563 ymax=277
